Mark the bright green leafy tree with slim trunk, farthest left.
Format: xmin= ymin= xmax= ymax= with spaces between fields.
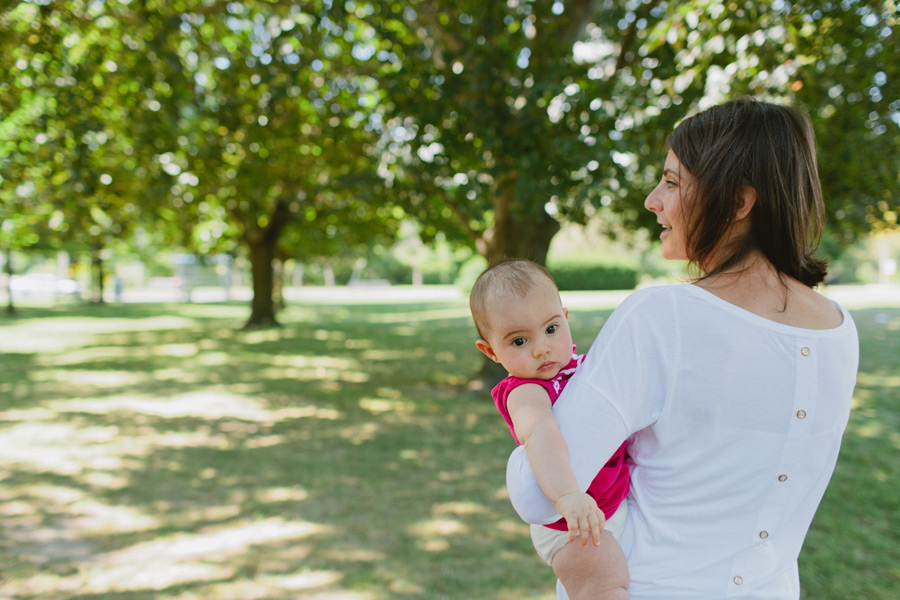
xmin=0 ymin=2 xmax=179 ymax=302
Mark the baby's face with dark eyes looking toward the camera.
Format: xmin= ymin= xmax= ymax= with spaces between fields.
xmin=486 ymin=286 xmax=572 ymax=380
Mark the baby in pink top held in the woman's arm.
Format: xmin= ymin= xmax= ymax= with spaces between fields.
xmin=469 ymin=260 xmax=629 ymax=600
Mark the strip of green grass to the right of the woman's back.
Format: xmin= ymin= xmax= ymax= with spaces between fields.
xmin=800 ymin=307 xmax=900 ymax=600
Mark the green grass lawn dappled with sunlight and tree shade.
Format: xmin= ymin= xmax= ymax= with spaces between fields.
xmin=0 ymin=288 xmax=900 ymax=600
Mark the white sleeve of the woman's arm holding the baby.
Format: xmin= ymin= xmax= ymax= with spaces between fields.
xmin=506 ymin=291 xmax=678 ymax=523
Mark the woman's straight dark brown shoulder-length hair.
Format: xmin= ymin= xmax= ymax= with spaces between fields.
xmin=668 ymin=99 xmax=827 ymax=287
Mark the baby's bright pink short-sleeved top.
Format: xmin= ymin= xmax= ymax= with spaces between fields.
xmin=491 ymin=349 xmax=629 ymax=531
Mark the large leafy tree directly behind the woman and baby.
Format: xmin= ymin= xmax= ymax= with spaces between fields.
xmin=375 ymin=0 xmax=900 ymax=262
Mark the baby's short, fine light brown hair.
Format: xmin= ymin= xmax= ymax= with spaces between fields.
xmin=469 ymin=259 xmax=559 ymax=339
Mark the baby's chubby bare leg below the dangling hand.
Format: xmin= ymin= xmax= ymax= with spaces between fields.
xmin=553 ymin=531 xmax=629 ymax=600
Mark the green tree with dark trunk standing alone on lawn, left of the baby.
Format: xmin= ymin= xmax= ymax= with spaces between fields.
xmin=163 ymin=3 xmax=394 ymax=325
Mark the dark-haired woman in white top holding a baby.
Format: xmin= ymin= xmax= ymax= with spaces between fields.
xmin=507 ymin=100 xmax=859 ymax=600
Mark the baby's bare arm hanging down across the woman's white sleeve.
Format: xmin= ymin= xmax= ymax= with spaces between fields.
xmin=506 ymin=383 xmax=604 ymax=547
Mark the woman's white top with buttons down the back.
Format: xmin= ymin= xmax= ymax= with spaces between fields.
xmin=507 ymin=284 xmax=859 ymax=600
